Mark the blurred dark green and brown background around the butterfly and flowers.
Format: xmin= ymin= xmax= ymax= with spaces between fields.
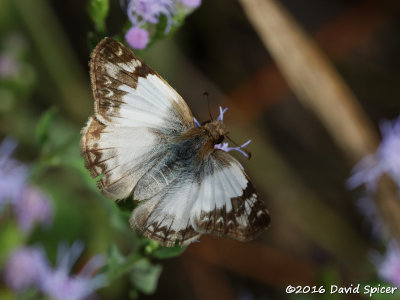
xmin=0 ymin=0 xmax=400 ymax=299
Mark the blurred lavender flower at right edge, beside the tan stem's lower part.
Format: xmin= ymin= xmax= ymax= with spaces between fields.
xmin=347 ymin=117 xmax=400 ymax=191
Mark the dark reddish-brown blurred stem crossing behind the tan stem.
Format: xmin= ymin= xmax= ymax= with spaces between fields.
xmin=227 ymin=0 xmax=390 ymax=122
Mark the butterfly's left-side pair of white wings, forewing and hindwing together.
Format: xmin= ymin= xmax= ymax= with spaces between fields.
xmin=81 ymin=38 xmax=193 ymax=199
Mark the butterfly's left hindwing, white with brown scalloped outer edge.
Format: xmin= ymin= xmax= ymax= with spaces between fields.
xmin=81 ymin=118 xmax=162 ymax=199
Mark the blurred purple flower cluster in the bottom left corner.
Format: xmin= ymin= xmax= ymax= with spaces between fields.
xmin=4 ymin=242 xmax=107 ymax=300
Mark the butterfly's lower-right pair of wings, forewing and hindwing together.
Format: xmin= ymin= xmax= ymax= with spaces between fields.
xmin=131 ymin=146 xmax=270 ymax=246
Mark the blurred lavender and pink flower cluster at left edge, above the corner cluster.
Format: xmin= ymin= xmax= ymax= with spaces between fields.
xmin=0 ymin=138 xmax=53 ymax=234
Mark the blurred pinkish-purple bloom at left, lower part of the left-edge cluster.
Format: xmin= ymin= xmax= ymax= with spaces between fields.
xmin=15 ymin=186 xmax=53 ymax=233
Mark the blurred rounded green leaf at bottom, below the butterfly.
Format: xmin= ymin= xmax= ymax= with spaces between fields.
xmin=130 ymin=259 xmax=162 ymax=294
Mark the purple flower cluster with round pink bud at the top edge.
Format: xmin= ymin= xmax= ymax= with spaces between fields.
xmin=123 ymin=0 xmax=201 ymax=49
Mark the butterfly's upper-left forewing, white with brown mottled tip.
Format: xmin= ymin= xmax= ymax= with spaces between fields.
xmin=90 ymin=38 xmax=193 ymax=131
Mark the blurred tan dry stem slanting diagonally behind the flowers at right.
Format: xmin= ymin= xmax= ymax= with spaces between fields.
xmin=239 ymin=0 xmax=400 ymax=241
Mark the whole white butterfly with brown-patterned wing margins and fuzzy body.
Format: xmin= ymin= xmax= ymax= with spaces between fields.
xmin=81 ymin=38 xmax=270 ymax=246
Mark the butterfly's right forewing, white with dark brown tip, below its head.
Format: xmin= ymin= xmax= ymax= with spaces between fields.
xmin=191 ymin=150 xmax=270 ymax=241
